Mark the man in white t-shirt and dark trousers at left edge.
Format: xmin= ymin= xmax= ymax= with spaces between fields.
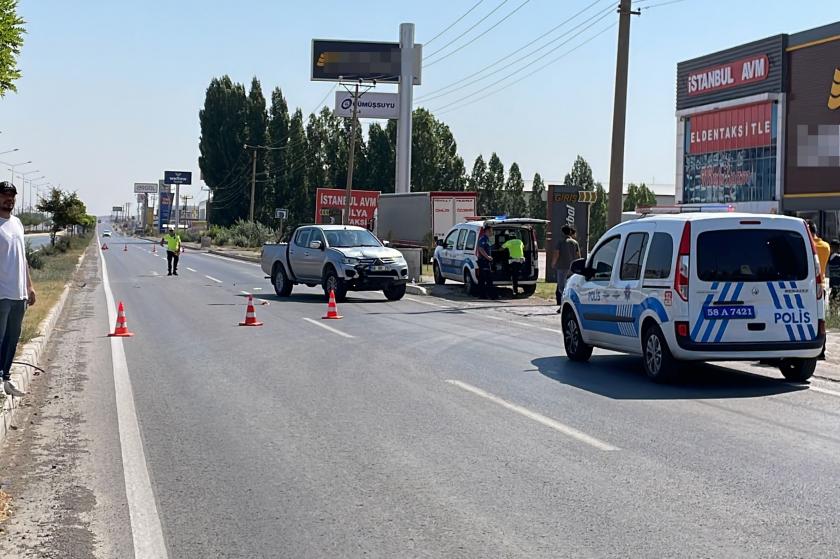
xmin=0 ymin=181 xmax=35 ymax=398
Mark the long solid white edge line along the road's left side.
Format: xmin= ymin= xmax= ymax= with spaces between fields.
xmin=99 ymin=249 xmax=167 ymax=559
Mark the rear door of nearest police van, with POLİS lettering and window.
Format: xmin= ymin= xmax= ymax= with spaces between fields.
xmin=689 ymin=219 xmax=819 ymax=344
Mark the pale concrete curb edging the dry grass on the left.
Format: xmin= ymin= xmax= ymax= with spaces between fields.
xmin=0 ymin=243 xmax=89 ymax=446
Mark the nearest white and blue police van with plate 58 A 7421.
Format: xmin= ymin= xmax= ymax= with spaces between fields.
xmin=561 ymin=213 xmax=825 ymax=382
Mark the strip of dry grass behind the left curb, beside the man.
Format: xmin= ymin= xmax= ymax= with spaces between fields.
xmin=19 ymin=236 xmax=91 ymax=345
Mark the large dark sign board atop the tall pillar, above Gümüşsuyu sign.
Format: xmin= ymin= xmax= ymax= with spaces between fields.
xmin=311 ymin=39 xmax=423 ymax=85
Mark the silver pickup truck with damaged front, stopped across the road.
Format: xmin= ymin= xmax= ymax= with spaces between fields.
xmin=261 ymin=225 xmax=408 ymax=302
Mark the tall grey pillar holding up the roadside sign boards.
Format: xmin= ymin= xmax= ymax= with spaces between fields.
xmin=396 ymin=23 xmax=415 ymax=193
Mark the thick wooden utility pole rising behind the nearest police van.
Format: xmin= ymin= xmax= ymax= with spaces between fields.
xmin=607 ymin=0 xmax=640 ymax=227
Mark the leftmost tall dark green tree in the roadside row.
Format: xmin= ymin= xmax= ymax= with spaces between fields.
xmin=198 ymin=76 xmax=251 ymax=225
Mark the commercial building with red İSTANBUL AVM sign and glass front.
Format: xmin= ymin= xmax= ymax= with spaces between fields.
xmin=676 ymin=22 xmax=840 ymax=238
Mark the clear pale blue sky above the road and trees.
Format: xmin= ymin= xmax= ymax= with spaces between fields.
xmin=0 ymin=0 xmax=840 ymax=215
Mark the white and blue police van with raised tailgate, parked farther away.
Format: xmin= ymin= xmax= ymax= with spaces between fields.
xmin=432 ymin=217 xmax=548 ymax=296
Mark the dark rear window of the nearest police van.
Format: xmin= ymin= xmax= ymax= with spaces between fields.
xmin=697 ymin=229 xmax=809 ymax=282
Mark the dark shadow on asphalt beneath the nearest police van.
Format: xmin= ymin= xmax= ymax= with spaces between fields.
xmin=531 ymin=355 xmax=808 ymax=400
